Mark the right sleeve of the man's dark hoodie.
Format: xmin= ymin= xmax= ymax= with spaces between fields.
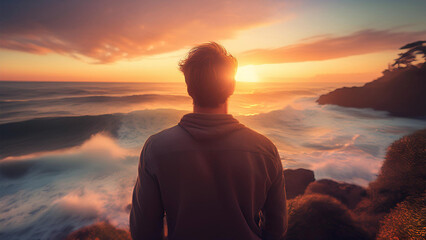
xmin=262 ymin=148 xmax=288 ymax=240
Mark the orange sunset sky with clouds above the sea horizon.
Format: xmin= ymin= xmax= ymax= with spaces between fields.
xmin=0 ymin=0 xmax=426 ymax=82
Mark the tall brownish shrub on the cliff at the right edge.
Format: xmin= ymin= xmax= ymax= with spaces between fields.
xmin=369 ymin=129 xmax=426 ymax=213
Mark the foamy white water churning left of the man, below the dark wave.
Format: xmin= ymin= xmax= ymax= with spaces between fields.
xmin=0 ymin=134 xmax=138 ymax=239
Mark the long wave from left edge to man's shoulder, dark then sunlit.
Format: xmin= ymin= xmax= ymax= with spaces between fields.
xmin=0 ymin=109 xmax=185 ymax=160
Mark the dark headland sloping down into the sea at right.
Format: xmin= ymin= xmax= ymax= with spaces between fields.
xmin=317 ymin=64 xmax=426 ymax=117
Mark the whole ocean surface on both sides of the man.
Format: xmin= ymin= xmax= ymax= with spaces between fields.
xmin=0 ymin=82 xmax=426 ymax=240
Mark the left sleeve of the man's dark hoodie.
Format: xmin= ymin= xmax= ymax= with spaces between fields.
xmin=130 ymin=139 xmax=164 ymax=240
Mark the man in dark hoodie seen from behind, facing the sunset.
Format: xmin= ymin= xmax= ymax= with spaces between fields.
xmin=130 ymin=42 xmax=287 ymax=240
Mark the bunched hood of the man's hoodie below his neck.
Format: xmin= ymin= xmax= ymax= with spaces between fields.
xmin=178 ymin=113 xmax=245 ymax=140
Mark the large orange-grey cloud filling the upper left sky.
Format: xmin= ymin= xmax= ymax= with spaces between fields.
xmin=0 ymin=0 xmax=282 ymax=63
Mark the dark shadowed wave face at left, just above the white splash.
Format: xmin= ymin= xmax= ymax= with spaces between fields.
xmin=0 ymin=114 xmax=122 ymax=159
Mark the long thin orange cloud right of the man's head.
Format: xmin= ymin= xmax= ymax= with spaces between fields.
xmin=238 ymin=29 xmax=426 ymax=65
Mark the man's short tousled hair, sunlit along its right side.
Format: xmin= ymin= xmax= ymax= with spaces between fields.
xmin=179 ymin=42 xmax=238 ymax=108
